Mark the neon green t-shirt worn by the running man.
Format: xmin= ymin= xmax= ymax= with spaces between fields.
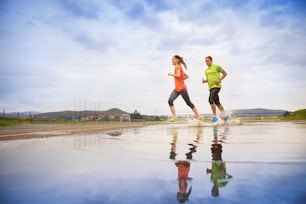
xmin=205 ymin=64 xmax=223 ymax=89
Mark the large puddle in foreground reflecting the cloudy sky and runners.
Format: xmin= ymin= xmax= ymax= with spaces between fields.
xmin=0 ymin=122 xmax=306 ymax=203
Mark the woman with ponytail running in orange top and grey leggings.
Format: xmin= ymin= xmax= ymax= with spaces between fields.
xmin=168 ymin=55 xmax=200 ymax=122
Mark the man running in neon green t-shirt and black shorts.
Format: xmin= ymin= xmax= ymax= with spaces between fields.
xmin=202 ymin=56 xmax=229 ymax=123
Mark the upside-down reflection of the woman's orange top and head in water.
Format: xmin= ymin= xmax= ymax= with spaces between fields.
xmin=175 ymin=160 xmax=192 ymax=203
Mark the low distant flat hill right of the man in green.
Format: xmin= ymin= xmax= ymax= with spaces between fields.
xmin=232 ymin=108 xmax=290 ymax=116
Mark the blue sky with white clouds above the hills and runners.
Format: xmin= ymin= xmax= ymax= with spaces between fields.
xmin=0 ymin=0 xmax=306 ymax=114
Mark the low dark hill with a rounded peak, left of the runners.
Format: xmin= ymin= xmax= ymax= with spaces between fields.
xmin=34 ymin=108 xmax=129 ymax=120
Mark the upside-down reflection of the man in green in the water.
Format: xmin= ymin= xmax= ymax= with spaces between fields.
xmin=206 ymin=127 xmax=232 ymax=197
